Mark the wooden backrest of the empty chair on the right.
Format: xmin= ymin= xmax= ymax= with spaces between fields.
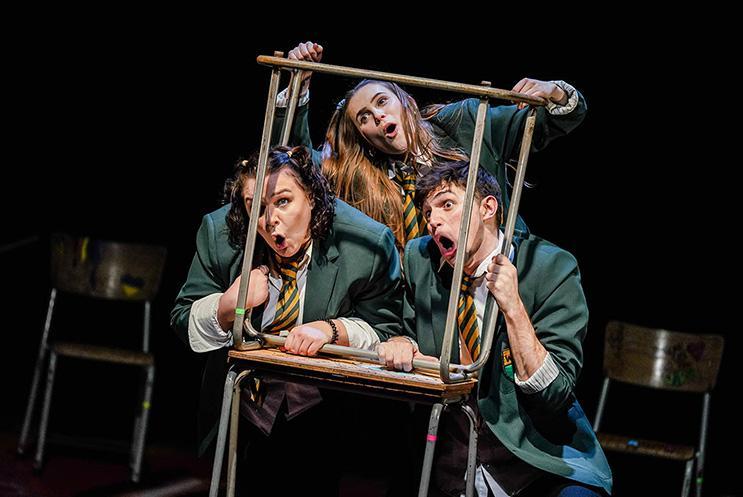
xmin=604 ymin=321 xmax=725 ymax=392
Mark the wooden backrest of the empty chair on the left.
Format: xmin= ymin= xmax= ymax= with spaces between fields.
xmin=51 ymin=234 xmax=166 ymax=301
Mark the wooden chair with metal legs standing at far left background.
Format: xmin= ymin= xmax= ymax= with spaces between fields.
xmin=18 ymin=234 xmax=166 ymax=482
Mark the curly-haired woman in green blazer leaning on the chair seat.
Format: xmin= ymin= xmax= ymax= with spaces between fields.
xmin=171 ymin=147 xmax=402 ymax=495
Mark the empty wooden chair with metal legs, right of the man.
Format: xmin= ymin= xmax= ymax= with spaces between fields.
xmin=593 ymin=321 xmax=724 ymax=497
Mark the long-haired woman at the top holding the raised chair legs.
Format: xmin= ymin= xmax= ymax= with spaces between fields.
xmin=279 ymin=41 xmax=586 ymax=249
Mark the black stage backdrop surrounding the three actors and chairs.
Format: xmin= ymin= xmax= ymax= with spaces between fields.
xmin=0 ymin=15 xmax=741 ymax=495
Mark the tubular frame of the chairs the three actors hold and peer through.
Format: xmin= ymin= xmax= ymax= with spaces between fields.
xmin=209 ymin=52 xmax=546 ymax=497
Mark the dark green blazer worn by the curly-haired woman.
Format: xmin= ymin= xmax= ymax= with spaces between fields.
xmin=170 ymin=200 xmax=402 ymax=452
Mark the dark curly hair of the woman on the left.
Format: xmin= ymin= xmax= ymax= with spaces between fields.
xmin=224 ymin=146 xmax=335 ymax=248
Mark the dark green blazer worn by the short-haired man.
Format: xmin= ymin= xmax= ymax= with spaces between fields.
xmin=403 ymin=236 xmax=612 ymax=492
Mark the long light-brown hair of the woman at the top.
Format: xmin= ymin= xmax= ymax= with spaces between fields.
xmin=323 ymin=79 xmax=468 ymax=249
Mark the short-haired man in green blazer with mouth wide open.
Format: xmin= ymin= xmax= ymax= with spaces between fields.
xmin=378 ymin=162 xmax=612 ymax=496
